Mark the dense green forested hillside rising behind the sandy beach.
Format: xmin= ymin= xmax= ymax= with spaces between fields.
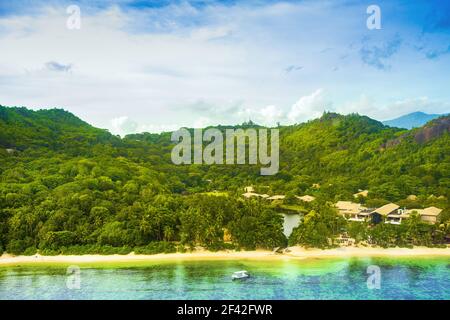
xmin=0 ymin=106 xmax=450 ymax=254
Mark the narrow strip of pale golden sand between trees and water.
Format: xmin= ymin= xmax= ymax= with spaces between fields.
xmin=0 ymin=246 xmax=450 ymax=267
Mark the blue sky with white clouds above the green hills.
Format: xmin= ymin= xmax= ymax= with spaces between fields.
xmin=0 ymin=0 xmax=450 ymax=135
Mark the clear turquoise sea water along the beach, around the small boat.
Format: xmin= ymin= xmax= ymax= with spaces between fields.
xmin=0 ymin=258 xmax=450 ymax=300
